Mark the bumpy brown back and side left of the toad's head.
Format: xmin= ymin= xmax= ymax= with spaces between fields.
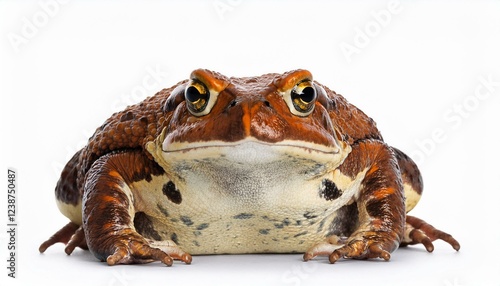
xmin=56 ymin=83 xmax=181 ymax=205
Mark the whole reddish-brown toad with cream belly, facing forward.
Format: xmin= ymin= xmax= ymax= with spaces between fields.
xmin=40 ymin=69 xmax=460 ymax=266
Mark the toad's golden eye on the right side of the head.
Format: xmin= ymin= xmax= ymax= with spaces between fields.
xmin=285 ymin=79 xmax=317 ymax=116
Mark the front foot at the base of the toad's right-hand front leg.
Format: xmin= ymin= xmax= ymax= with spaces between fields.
xmin=304 ymin=232 xmax=394 ymax=263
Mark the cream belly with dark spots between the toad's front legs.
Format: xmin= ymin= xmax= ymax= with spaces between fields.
xmin=132 ymin=171 xmax=356 ymax=255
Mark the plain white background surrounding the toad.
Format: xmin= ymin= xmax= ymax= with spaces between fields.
xmin=0 ymin=0 xmax=500 ymax=286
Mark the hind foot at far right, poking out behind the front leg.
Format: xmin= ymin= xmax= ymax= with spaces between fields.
xmin=401 ymin=216 xmax=460 ymax=252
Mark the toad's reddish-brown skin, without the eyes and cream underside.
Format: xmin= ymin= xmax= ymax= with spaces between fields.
xmin=40 ymin=70 xmax=459 ymax=265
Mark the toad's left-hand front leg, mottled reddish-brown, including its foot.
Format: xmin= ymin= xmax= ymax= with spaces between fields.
xmin=83 ymin=152 xmax=191 ymax=266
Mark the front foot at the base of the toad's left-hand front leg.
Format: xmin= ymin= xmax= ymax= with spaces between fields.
xmin=106 ymin=232 xmax=192 ymax=266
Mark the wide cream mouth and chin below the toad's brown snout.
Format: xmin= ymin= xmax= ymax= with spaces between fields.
xmin=146 ymin=131 xmax=351 ymax=183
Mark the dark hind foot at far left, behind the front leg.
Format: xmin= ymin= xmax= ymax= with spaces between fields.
xmin=38 ymin=222 xmax=88 ymax=255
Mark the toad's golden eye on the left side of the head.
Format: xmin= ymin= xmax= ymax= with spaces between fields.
xmin=184 ymin=79 xmax=217 ymax=116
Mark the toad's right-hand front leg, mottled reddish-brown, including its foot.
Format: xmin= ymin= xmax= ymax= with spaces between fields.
xmin=304 ymin=140 xmax=405 ymax=263
